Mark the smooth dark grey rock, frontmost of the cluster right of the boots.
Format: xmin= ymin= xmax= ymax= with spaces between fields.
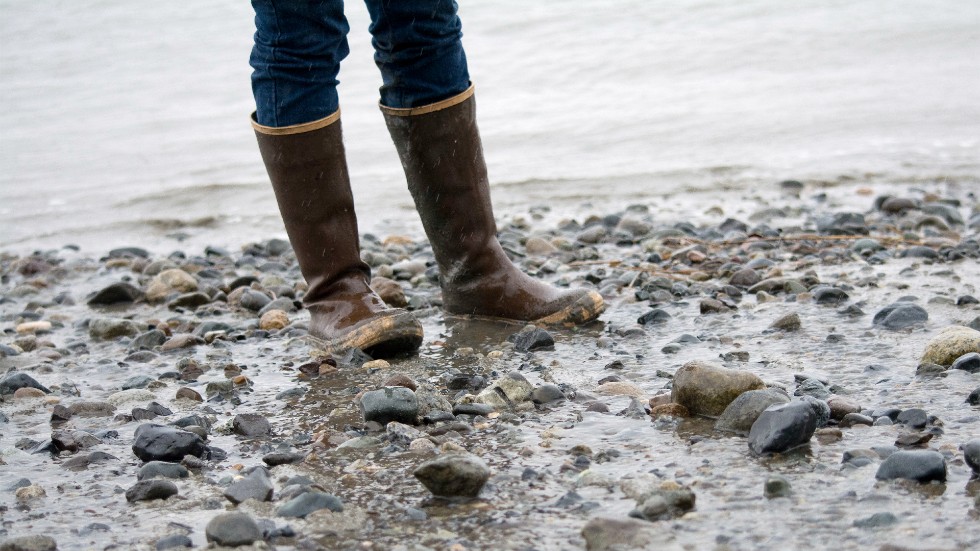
xmin=749 ymin=401 xmax=817 ymax=455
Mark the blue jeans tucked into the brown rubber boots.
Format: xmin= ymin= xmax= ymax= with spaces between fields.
xmin=249 ymin=0 xmax=470 ymax=127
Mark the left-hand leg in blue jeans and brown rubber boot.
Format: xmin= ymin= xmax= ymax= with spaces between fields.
xmin=252 ymin=0 xmax=422 ymax=356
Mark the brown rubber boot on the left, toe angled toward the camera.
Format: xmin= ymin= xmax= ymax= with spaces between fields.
xmin=252 ymin=111 xmax=422 ymax=357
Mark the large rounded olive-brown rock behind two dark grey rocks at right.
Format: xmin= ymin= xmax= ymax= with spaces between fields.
xmin=670 ymin=361 xmax=766 ymax=417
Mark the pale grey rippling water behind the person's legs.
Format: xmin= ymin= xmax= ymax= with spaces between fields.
xmin=0 ymin=0 xmax=980 ymax=252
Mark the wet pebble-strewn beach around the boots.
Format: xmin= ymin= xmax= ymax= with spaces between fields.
xmin=0 ymin=180 xmax=980 ymax=551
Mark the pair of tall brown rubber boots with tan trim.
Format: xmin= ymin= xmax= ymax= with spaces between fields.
xmin=253 ymin=87 xmax=603 ymax=358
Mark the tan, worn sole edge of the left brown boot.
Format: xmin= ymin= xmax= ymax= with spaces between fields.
xmin=307 ymin=312 xmax=423 ymax=358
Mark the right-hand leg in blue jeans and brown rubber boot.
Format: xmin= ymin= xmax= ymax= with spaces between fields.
xmin=367 ymin=0 xmax=604 ymax=325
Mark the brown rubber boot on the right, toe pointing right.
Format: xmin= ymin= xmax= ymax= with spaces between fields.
xmin=381 ymin=86 xmax=604 ymax=326
